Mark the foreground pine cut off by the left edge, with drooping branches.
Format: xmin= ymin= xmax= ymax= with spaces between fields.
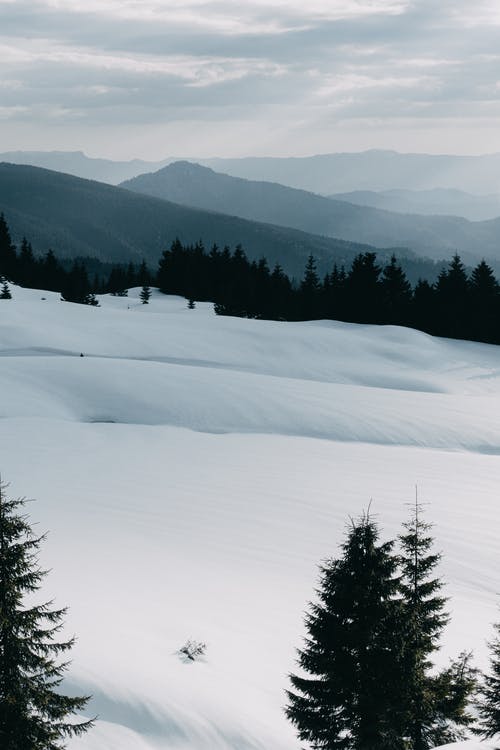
xmin=0 ymin=483 xmax=93 ymax=750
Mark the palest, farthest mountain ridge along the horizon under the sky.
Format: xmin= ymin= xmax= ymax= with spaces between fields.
xmin=4 ymin=150 xmax=500 ymax=197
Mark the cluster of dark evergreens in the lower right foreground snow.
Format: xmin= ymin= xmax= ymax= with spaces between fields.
xmin=286 ymin=503 xmax=500 ymax=750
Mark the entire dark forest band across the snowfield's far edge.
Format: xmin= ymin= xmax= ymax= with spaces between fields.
xmin=0 ymin=215 xmax=500 ymax=344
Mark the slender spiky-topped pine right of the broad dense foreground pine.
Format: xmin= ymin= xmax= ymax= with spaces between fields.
xmin=399 ymin=500 xmax=475 ymax=750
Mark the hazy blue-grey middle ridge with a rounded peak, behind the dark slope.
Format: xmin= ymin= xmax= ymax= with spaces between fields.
xmin=122 ymin=161 xmax=500 ymax=263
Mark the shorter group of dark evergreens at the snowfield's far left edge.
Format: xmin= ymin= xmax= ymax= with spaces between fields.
xmin=0 ymin=214 xmax=154 ymax=305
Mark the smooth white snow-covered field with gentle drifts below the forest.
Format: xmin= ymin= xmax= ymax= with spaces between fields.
xmin=0 ymin=288 xmax=500 ymax=750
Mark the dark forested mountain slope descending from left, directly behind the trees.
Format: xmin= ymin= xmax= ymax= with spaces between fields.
xmin=0 ymin=163 xmax=403 ymax=277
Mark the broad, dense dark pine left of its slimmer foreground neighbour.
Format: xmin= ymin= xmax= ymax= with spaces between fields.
xmin=286 ymin=515 xmax=404 ymax=750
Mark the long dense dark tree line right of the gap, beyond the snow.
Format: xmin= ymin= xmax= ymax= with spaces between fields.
xmin=157 ymin=240 xmax=500 ymax=343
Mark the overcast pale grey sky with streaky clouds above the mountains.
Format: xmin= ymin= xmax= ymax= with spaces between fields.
xmin=0 ymin=0 xmax=500 ymax=159
